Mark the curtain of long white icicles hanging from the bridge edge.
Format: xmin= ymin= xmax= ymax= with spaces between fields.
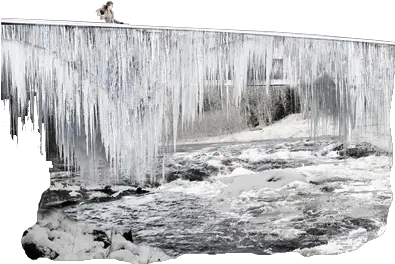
xmin=0 ymin=19 xmax=395 ymax=185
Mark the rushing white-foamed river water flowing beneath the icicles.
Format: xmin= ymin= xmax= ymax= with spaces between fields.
xmin=65 ymin=138 xmax=392 ymax=256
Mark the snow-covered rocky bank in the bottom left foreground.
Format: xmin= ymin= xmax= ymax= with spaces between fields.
xmin=21 ymin=210 xmax=171 ymax=264
